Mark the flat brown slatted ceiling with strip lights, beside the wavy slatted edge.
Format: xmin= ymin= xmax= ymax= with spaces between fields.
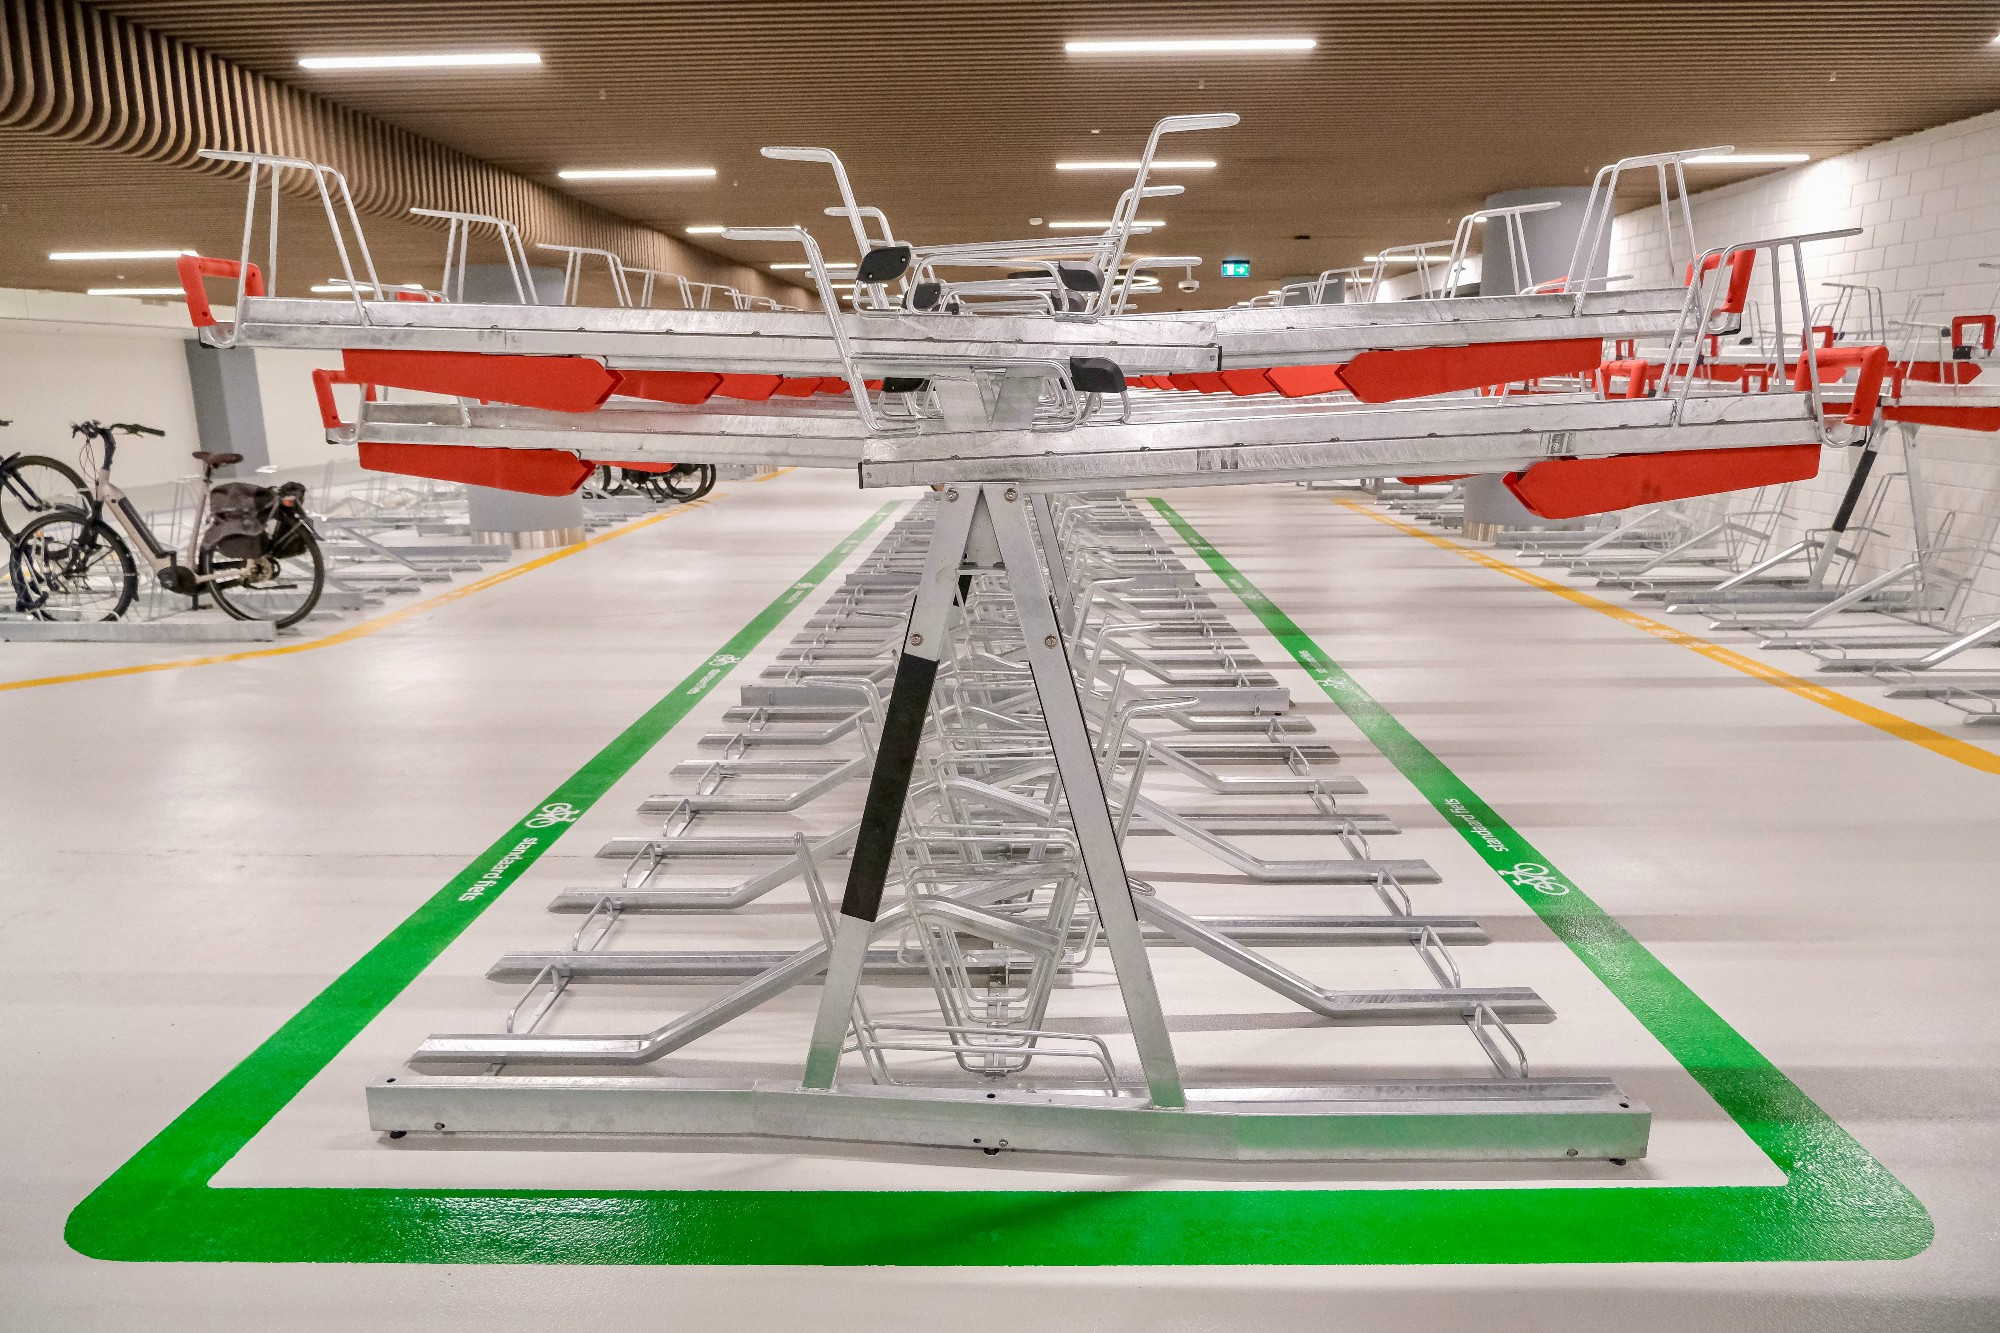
xmin=11 ymin=0 xmax=2000 ymax=308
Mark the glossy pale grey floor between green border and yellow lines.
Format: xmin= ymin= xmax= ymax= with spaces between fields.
xmin=0 ymin=472 xmax=2000 ymax=1329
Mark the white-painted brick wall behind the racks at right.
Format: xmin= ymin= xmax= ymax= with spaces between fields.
xmin=1610 ymin=112 xmax=2000 ymax=614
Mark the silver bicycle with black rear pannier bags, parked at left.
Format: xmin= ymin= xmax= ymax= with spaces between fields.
xmin=8 ymin=420 xmax=326 ymax=628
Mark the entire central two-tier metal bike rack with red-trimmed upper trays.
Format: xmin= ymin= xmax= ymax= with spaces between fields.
xmin=125 ymin=114 xmax=1920 ymax=1161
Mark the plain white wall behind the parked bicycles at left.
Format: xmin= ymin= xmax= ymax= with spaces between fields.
xmin=0 ymin=290 xmax=356 ymax=498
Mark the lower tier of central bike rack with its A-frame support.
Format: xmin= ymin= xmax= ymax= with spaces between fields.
xmin=370 ymin=484 xmax=1646 ymax=1161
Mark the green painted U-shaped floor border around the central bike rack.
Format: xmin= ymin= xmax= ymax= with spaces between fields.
xmin=66 ymin=500 xmax=1932 ymax=1265
